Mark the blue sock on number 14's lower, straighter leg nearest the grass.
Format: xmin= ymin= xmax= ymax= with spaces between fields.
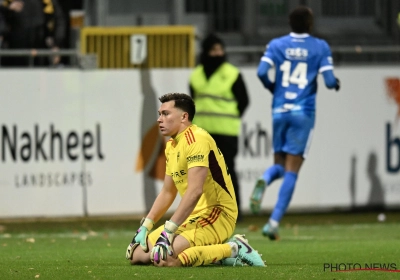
xmin=271 ymin=171 xmax=297 ymax=222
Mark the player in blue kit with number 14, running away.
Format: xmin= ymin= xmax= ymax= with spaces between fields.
xmin=250 ymin=6 xmax=340 ymax=240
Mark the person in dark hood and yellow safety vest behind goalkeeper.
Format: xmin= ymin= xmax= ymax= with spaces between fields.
xmin=190 ymin=34 xmax=249 ymax=221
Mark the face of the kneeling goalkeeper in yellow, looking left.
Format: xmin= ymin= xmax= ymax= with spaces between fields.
xmin=157 ymin=100 xmax=190 ymax=138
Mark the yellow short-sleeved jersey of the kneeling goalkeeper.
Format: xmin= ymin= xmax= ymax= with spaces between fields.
xmin=165 ymin=124 xmax=238 ymax=220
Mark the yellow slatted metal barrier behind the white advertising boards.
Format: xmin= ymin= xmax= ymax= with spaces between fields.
xmin=80 ymin=26 xmax=195 ymax=68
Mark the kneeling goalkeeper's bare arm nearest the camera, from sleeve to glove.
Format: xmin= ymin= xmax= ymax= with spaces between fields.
xmin=171 ymin=166 xmax=208 ymax=225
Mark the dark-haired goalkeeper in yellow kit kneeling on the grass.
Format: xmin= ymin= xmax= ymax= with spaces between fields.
xmin=126 ymin=93 xmax=265 ymax=267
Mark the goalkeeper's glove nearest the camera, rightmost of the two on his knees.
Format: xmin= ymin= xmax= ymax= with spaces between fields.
xmin=150 ymin=221 xmax=179 ymax=263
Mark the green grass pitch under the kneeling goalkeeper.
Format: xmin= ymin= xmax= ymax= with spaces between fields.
xmin=0 ymin=212 xmax=400 ymax=280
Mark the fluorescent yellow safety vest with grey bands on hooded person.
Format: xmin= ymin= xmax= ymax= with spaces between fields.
xmin=190 ymin=62 xmax=241 ymax=136
